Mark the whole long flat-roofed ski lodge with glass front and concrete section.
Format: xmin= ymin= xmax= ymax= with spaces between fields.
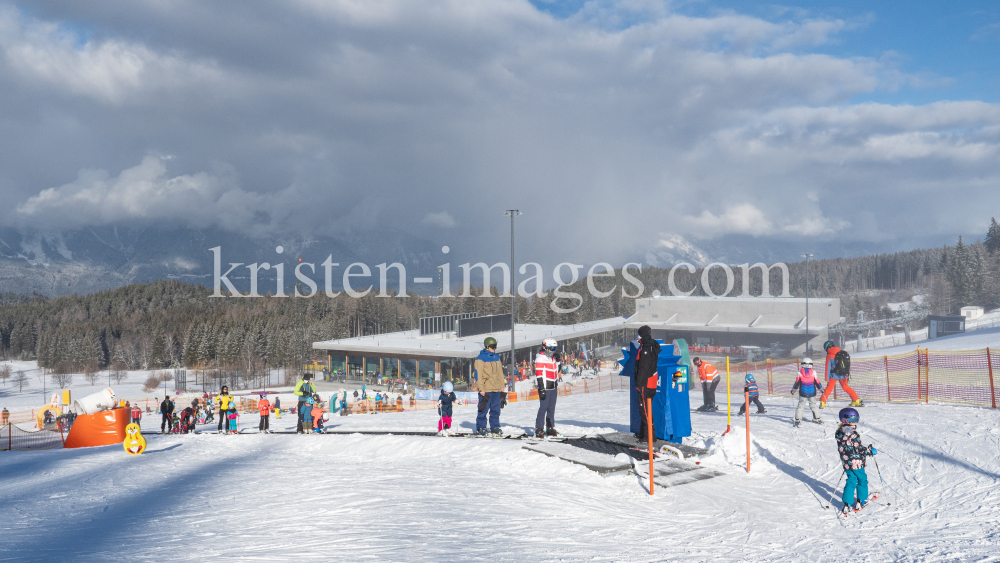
xmin=313 ymin=297 xmax=842 ymax=382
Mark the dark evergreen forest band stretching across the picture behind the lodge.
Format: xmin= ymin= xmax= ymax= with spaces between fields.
xmin=0 ymin=221 xmax=1000 ymax=378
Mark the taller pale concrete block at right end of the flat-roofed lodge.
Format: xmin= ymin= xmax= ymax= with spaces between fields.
xmin=625 ymin=297 xmax=841 ymax=355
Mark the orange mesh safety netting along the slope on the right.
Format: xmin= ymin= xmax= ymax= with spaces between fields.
xmin=729 ymin=348 xmax=1000 ymax=408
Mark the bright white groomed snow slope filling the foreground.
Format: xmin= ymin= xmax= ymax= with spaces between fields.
xmin=0 ymin=330 xmax=1000 ymax=562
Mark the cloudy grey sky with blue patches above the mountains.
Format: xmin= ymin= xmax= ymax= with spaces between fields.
xmin=0 ymin=0 xmax=1000 ymax=262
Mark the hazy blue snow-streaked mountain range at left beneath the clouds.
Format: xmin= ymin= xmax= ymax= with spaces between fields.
xmin=0 ymin=227 xmax=439 ymax=296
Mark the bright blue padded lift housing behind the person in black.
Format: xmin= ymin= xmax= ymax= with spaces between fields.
xmin=618 ymin=340 xmax=691 ymax=444
